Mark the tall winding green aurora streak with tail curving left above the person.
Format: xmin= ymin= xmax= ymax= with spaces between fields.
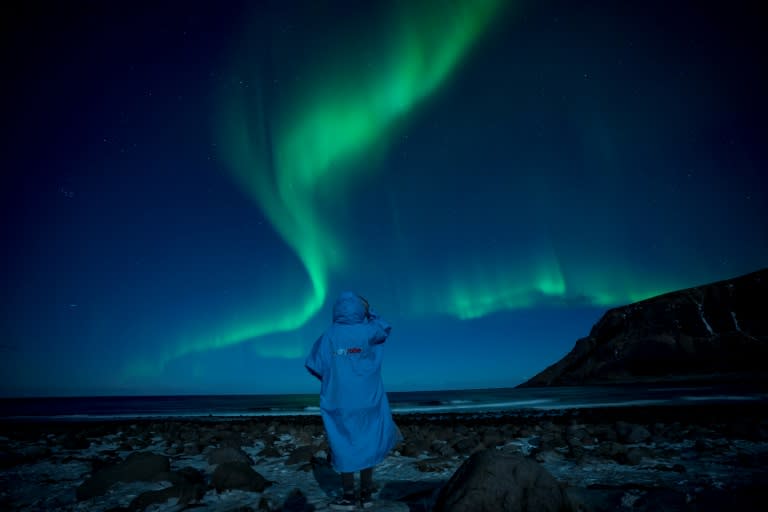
xmin=124 ymin=0 xmax=503 ymax=374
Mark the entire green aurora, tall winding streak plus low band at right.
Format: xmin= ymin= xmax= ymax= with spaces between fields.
xmin=118 ymin=0 xmax=704 ymax=377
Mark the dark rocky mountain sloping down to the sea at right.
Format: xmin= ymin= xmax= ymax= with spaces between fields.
xmin=519 ymin=268 xmax=768 ymax=387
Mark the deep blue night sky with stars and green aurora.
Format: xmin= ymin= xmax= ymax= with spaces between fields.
xmin=0 ymin=0 xmax=768 ymax=395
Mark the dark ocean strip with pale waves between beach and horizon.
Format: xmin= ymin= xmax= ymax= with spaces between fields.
xmin=0 ymin=385 xmax=768 ymax=421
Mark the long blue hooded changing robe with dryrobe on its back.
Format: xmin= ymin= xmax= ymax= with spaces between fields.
xmin=306 ymin=292 xmax=400 ymax=473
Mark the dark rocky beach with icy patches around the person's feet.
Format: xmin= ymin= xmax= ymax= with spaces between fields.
xmin=0 ymin=400 xmax=768 ymax=512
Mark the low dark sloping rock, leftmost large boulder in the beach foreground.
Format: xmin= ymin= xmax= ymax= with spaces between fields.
xmin=76 ymin=452 xmax=171 ymax=500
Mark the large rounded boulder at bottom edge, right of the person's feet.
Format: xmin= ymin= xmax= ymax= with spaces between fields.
xmin=434 ymin=449 xmax=572 ymax=512
